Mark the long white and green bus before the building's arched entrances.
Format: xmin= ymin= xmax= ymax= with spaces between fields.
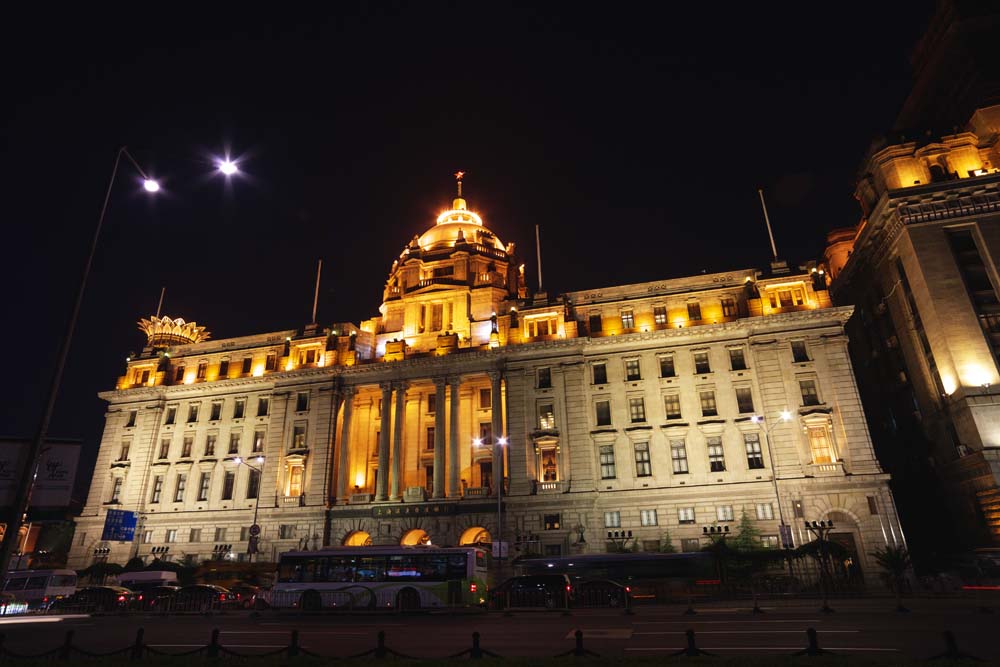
xmin=268 ymin=546 xmax=488 ymax=610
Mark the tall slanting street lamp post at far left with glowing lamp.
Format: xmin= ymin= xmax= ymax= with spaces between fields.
xmin=0 ymin=146 xmax=160 ymax=574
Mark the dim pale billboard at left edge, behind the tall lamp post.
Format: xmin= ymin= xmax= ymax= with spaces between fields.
xmin=0 ymin=440 xmax=80 ymax=507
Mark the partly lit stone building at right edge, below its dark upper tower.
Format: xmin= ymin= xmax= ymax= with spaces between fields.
xmin=826 ymin=106 xmax=1000 ymax=564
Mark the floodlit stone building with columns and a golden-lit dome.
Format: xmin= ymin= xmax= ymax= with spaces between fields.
xmin=71 ymin=180 xmax=903 ymax=570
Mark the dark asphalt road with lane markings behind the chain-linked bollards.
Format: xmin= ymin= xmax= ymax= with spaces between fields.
xmin=0 ymin=599 xmax=1000 ymax=659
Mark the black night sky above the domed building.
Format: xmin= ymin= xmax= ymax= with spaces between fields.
xmin=0 ymin=0 xmax=934 ymax=497
